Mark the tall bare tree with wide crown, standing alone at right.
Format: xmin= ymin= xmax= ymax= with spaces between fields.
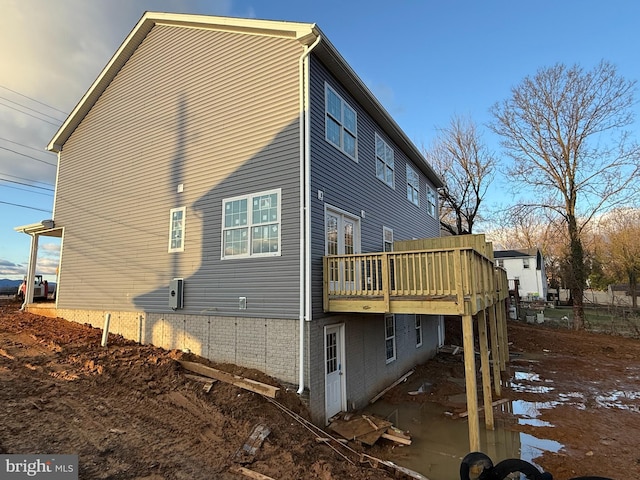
xmin=491 ymin=61 xmax=640 ymax=329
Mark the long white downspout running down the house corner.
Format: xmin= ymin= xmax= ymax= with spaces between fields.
xmin=298 ymin=35 xmax=322 ymax=395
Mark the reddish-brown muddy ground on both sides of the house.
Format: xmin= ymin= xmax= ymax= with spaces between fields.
xmin=0 ymin=302 xmax=640 ymax=480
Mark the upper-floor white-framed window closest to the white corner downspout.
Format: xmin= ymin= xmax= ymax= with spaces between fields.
xmin=325 ymin=84 xmax=358 ymax=160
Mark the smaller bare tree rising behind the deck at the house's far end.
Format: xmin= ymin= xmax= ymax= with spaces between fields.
xmin=425 ymin=116 xmax=496 ymax=235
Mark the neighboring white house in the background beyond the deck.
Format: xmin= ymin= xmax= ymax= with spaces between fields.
xmin=493 ymin=248 xmax=548 ymax=300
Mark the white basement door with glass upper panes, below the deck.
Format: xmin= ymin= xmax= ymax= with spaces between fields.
xmin=324 ymin=324 xmax=346 ymax=421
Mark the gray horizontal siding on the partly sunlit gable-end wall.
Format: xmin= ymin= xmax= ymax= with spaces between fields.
xmin=55 ymin=26 xmax=302 ymax=318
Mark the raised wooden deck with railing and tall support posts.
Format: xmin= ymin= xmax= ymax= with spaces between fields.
xmin=323 ymin=235 xmax=509 ymax=451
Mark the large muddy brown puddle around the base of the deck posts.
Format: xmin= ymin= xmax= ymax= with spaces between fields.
xmin=367 ymin=399 xmax=562 ymax=480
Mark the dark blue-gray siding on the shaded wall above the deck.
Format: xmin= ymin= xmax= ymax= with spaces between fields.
xmin=310 ymin=55 xmax=440 ymax=318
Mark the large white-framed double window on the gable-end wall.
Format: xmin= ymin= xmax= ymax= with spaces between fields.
xmin=222 ymin=189 xmax=281 ymax=258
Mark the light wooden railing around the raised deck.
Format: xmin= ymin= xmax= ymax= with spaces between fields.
xmin=324 ymin=247 xmax=506 ymax=315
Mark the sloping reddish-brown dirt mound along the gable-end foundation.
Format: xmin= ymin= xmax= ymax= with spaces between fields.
xmin=0 ymin=304 xmax=390 ymax=480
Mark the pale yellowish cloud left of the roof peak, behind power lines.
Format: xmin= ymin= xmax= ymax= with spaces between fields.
xmin=0 ymin=0 xmax=238 ymax=191
